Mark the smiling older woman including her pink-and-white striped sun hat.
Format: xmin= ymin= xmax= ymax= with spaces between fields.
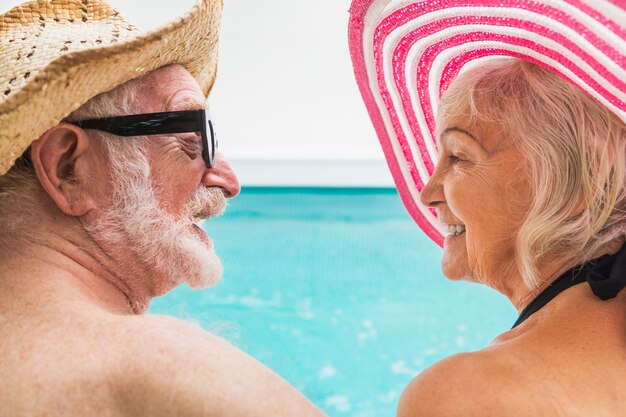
xmin=351 ymin=0 xmax=626 ymax=417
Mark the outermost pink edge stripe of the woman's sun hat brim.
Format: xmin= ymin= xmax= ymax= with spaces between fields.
xmin=349 ymin=0 xmax=444 ymax=246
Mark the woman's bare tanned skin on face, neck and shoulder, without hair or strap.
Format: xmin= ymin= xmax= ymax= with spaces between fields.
xmin=398 ymin=113 xmax=626 ymax=417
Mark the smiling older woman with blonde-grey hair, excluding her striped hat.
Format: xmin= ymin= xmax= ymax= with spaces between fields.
xmin=400 ymin=60 xmax=626 ymax=416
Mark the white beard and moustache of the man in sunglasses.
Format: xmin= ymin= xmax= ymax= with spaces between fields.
xmin=87 ymin=146 xmax=226 ymax=296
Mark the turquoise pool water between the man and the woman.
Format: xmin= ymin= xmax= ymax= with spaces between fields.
xmin=150 ymin=188 xmax=516 ymax=417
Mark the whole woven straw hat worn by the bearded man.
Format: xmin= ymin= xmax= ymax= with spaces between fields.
xmin=0 ymin=0 xmax=223 ymax=175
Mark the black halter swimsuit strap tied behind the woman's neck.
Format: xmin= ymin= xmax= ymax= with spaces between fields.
xmin=512 ymin=245 xmax=626 ymax=329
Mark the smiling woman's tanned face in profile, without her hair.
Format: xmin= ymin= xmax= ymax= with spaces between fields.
xmin=420 ymin=113 xmax=532 ymax=292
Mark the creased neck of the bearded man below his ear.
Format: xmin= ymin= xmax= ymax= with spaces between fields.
xmin=0 ymin=221 xmax=151 ymax=314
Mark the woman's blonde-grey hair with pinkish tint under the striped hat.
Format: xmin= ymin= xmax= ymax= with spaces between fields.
xmin=438 ymin=59 xmax=626 ymax=290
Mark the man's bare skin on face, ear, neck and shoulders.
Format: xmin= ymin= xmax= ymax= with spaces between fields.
xmin=0 ymin=66 xmax=322 ymax=417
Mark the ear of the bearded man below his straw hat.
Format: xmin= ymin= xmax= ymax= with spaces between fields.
xmin=31 ymin=123 xmax=94 ymax=216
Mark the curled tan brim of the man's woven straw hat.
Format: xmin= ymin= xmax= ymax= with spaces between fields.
xmin=0 ymin=0 xmax=223 ymax=175
